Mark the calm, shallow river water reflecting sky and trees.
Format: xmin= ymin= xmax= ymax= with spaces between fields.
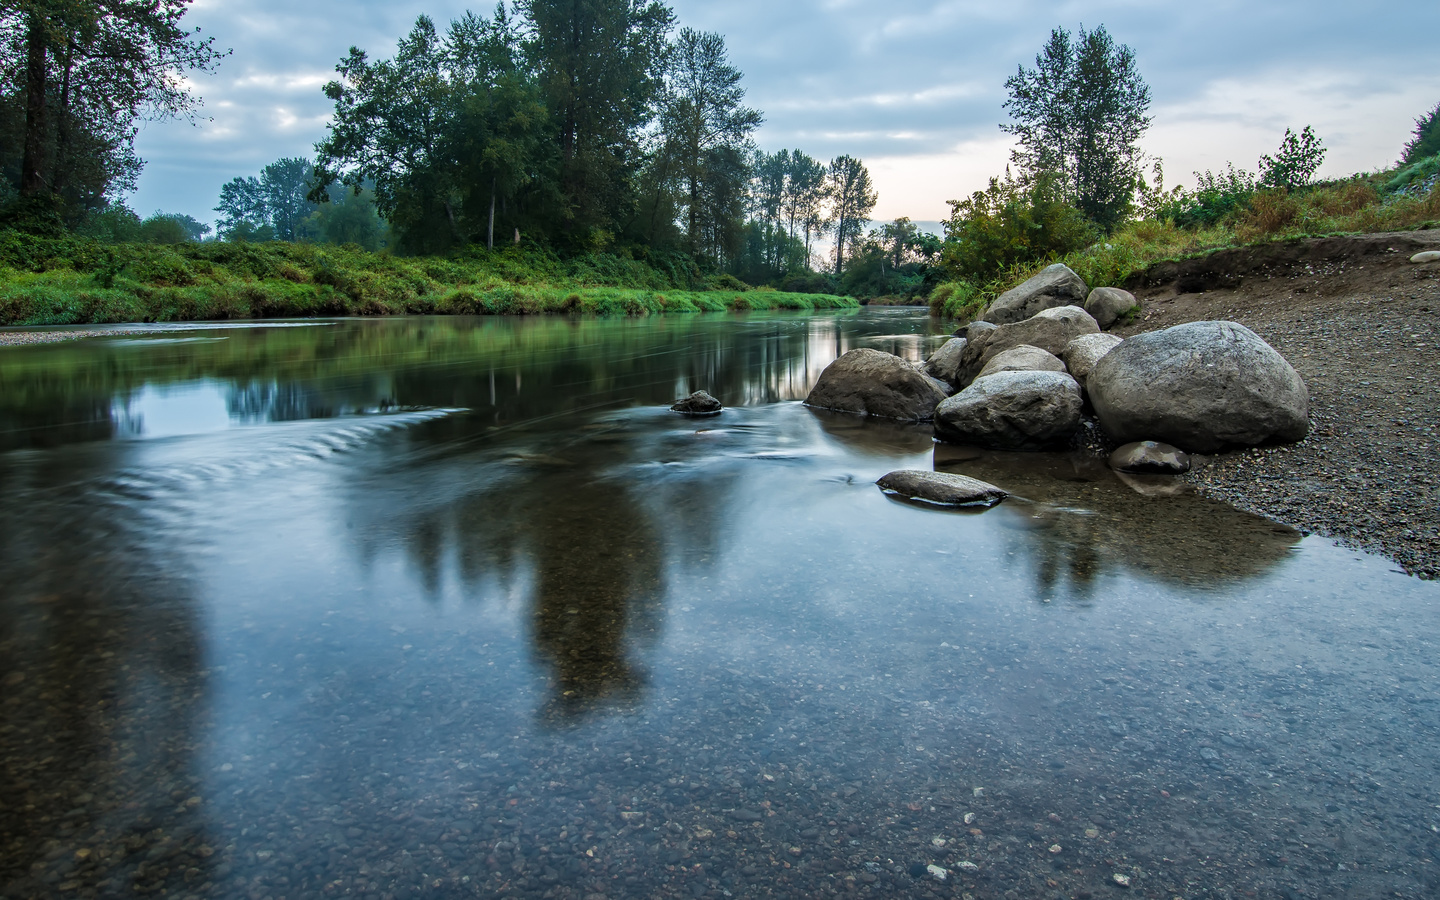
xmin=0 ymin=310 xmax=1440 ymax=900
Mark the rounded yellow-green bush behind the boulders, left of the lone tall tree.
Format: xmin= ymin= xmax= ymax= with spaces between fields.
xmin=940 ymin=176 xmax=1094 ymax=284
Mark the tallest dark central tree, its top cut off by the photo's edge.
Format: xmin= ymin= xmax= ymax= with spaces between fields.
xmin=517 ymin=0 xmax=674 ymax=246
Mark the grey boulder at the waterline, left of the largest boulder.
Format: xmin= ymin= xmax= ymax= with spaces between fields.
xmin=935 ymin=372 xmax=1081 ymax=451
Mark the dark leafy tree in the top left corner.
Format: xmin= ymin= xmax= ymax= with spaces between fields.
xmin=0 ymin=0 xmax=223 ymax=197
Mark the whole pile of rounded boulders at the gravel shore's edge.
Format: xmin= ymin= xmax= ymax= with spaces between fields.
xmin=806 ymin=265 xmax=1309 ymax=501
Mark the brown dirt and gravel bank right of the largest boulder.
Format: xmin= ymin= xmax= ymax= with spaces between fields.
xmin=1119 ymin=230 xmax=1440 ymax=577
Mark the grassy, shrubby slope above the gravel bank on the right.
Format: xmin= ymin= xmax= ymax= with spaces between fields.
xmin=930 ymin=164 xmax=1440 ymax=318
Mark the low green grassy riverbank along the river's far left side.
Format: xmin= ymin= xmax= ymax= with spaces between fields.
xmin=0 ymin=232 xmax=858 ymax=325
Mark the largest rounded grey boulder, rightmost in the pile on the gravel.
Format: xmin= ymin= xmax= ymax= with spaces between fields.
xmin=1086 ymin=321 xmax=1310 ymax=454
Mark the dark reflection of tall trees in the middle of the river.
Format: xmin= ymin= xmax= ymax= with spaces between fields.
xmin=362 ymin=416 xmax=733 ymax=723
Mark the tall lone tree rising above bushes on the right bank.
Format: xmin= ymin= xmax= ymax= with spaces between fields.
xmin=1001 ymin=26 xmax=1151 ymax=232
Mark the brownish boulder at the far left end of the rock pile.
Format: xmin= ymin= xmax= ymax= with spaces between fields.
xmin=805 ymin=347 xmax=950 ymax=422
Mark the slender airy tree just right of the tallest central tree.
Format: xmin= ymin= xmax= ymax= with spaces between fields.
xmin=660 ymin=29 xmax=763 ymax=253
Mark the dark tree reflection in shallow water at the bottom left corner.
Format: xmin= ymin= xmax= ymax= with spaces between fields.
xmin=0 ymin=445 xmax=212 ymax=897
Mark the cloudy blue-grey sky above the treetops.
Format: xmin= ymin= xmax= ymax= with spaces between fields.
xmin=130 ymin=0 xmax=1440 ymax=231
